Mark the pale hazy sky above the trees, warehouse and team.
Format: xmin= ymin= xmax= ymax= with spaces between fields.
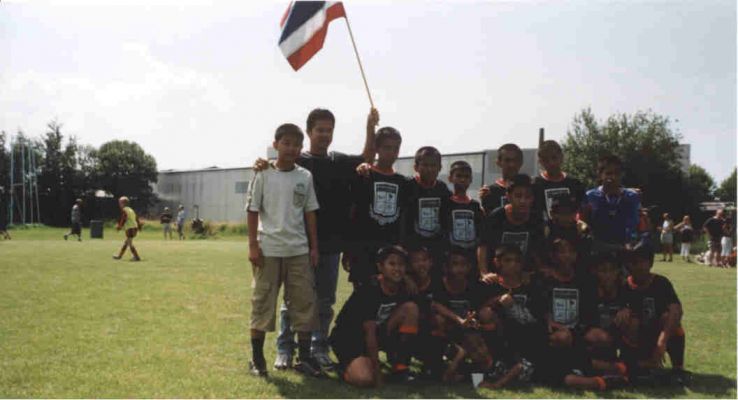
xmin=0 ymin=0 xmax=737 ymax=183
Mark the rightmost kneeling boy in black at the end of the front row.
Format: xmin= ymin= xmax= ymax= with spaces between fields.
xmin=624 ymin=242 xmax=689 ymax=384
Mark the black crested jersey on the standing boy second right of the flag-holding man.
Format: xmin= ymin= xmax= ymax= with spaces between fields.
xmin=407 ymin=177 xmax=451 ymax=243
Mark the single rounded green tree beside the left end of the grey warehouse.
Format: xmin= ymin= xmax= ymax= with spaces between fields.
xmin=95 ymin=140 xmax=158 ymax=208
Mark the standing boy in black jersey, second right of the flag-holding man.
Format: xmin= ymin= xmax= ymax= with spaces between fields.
xmin=403 ymin=146 xmax=451 ymax=277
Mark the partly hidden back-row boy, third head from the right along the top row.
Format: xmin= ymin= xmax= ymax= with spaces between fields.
xmin=479 ymin=143 xmax=523 ymax=213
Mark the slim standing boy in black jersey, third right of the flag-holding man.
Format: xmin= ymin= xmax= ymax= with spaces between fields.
xmin=446 ymin=161 xmax=482 ymax=279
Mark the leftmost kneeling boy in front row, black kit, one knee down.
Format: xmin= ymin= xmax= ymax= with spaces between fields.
xmin=330 ymin=246 xmax=418 ymax=387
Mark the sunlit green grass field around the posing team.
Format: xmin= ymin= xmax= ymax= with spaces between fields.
xmin=0 ymin=228 xmax=736 ymax=398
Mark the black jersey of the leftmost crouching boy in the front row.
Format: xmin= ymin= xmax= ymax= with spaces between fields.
xmin=332 ymin=279 xmax=411 ymax=340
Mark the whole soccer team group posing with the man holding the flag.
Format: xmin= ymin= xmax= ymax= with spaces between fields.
xmin=246 ymin=109 xmax=689 ymax=390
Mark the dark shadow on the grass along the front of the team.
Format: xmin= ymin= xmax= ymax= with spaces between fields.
xmin=267 ymin=373 xmax=736 ymax=399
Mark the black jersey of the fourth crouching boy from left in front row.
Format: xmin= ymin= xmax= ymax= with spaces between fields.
xmin=486 ymin=277 xmax=545 ymax=326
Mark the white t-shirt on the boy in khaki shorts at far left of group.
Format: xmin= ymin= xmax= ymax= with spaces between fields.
xmin=246 ymin=165 xmax=319 ymax=257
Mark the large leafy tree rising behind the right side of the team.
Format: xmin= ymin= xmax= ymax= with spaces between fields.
xmin=562 ymin=108 xmax=696 ymax=219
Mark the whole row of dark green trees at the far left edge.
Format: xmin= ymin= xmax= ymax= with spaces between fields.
xmin=0 ymin=121 xmax=157 ymax=226
